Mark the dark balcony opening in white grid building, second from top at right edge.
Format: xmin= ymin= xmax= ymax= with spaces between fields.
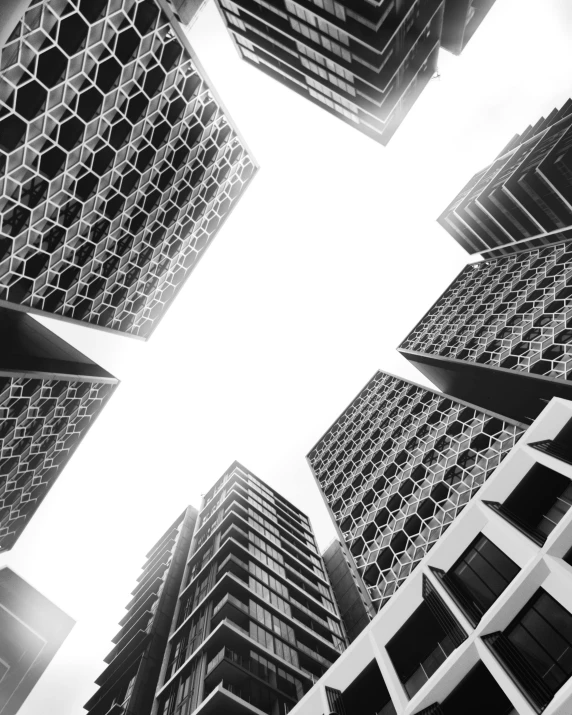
xmin=485 ymin=464 xmax=572 ymax=546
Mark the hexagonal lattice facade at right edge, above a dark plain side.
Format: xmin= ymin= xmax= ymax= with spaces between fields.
xmin=400 ymin=243 xmax=572 ymax=380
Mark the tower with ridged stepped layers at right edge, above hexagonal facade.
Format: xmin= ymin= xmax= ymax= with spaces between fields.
xmin=438 ymin=100 xmax=572 ymax=257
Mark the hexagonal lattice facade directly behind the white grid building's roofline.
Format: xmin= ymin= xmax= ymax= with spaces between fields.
xmin=308 ymin=372 xmax=523 ymax=608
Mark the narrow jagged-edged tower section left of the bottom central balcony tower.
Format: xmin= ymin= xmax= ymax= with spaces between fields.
xmin=85 ymin=506 xmax=197 ymax=715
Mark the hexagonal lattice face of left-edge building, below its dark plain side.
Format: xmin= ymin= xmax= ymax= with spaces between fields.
xmin=0 ymin=374 xmax=115 ymax=551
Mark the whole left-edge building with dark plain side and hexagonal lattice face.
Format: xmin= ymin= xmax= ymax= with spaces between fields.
xmin=0 ymin=308 xmax=117 ymax=551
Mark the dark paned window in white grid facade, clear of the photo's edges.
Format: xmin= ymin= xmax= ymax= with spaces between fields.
xmin=448 ymin=534 xmax=519 ymax=620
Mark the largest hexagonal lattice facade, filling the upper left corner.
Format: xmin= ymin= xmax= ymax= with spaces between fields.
xmin=0 ymin=0 xmax=255 ymax=337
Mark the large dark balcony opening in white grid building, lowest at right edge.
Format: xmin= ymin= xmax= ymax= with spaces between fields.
xmin=483 ymin=589 xmax=572 ymax=712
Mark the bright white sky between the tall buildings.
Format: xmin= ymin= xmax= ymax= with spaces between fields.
xmin=0 ymin=0 xmax=572 ymax=715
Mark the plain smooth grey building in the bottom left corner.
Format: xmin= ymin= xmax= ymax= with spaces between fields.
xmin=0 ymin=567 xmax=75 ymax=715
